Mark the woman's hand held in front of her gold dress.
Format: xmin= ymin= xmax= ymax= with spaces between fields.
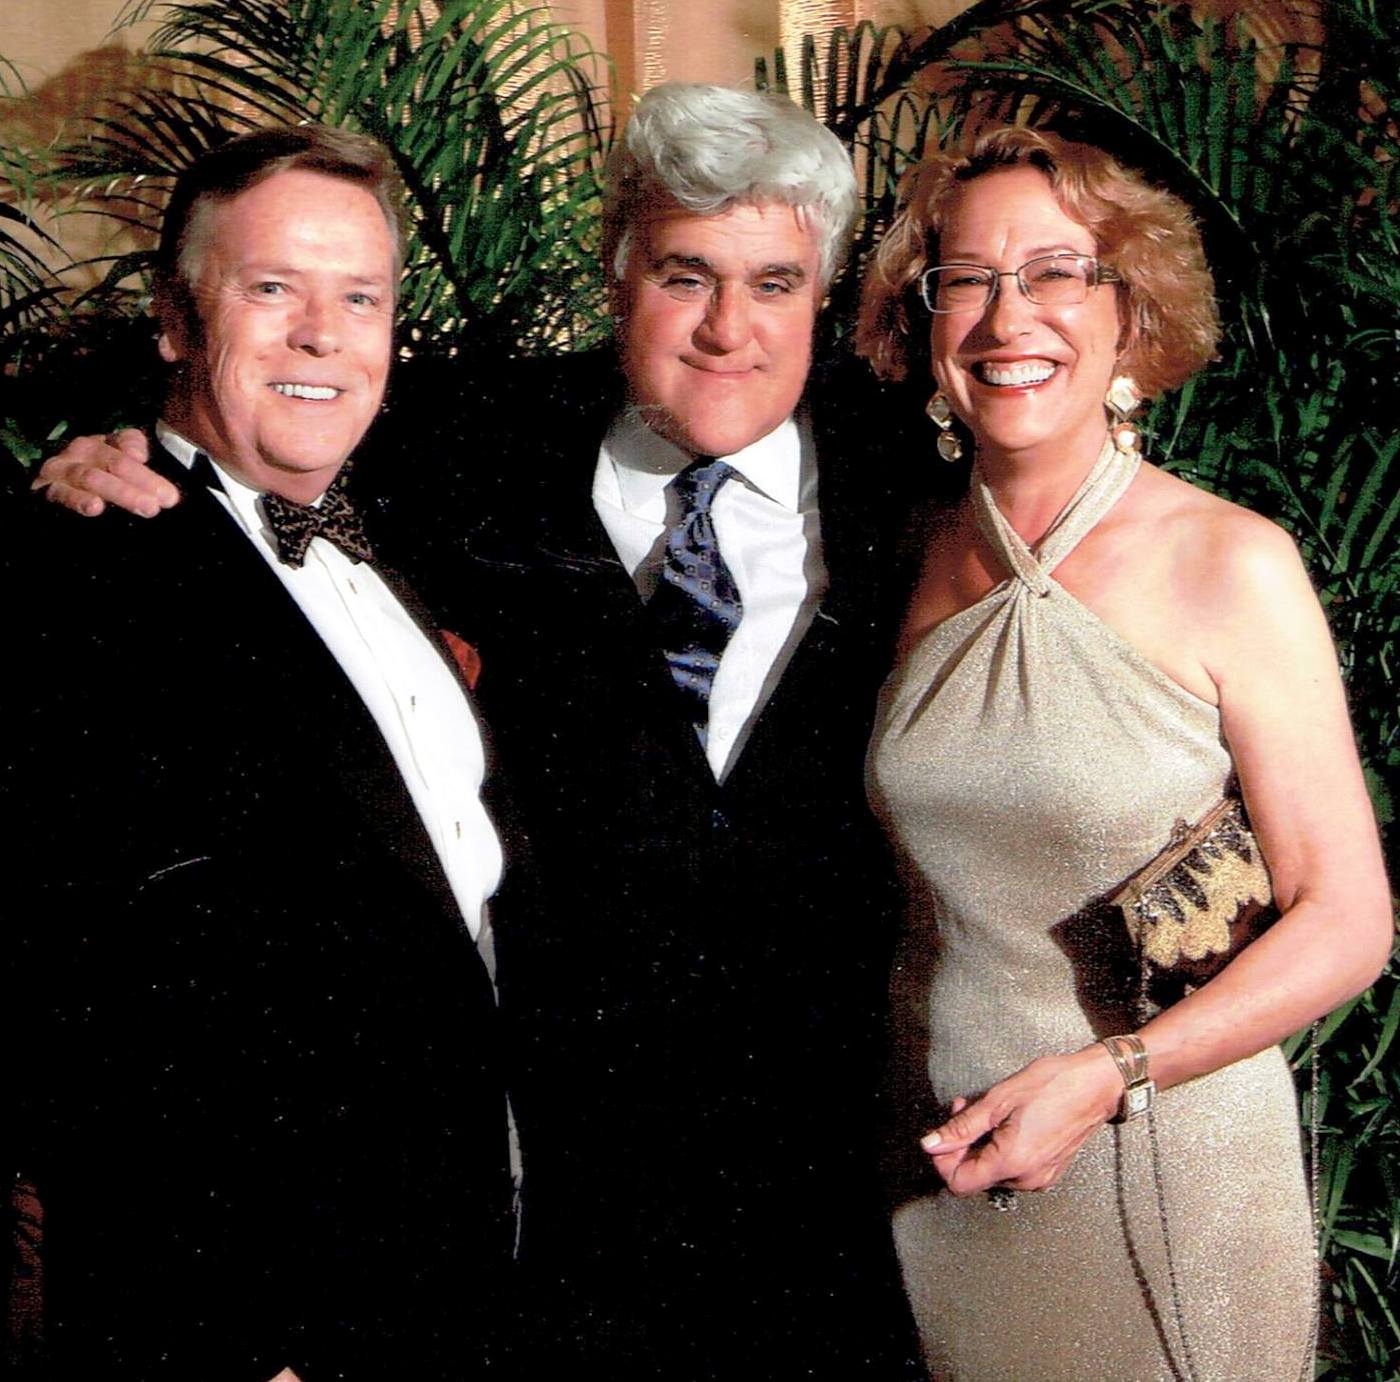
xmin=921 ymin=1045 xmax=1123 ymax=1194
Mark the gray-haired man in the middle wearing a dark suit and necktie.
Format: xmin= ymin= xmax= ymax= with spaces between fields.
xmin=35 ymin=84 xmax=927 ymax=1382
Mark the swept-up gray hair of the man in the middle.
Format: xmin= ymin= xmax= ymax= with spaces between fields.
xmin=602 ymin=81 xmax=860 ymax=286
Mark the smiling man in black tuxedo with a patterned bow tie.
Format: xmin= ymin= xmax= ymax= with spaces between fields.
xmin=3 ymin=127 xmax=511 ymax=1382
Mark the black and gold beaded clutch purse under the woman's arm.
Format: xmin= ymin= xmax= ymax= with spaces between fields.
xmin=1109 ymin=795 xmax=1278 ymax=983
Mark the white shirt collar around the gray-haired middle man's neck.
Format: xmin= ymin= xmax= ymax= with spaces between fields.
xmin=602 ymin=409 xmax=812 ymax=512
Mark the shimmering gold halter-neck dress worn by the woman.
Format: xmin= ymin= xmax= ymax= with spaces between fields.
xmin=869 ymin=444 xmax=1313 ymax=1382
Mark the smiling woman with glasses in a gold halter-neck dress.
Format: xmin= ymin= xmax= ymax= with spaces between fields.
xmin=861 ymin=130 xmax=1390 ymax=1382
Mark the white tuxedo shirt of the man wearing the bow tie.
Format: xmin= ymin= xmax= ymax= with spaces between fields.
xmin=155 ymin=423 xmax=501 ymax=968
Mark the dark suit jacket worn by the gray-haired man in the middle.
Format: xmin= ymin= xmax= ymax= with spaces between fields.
xmin=378 ymin=357 xmax=932 ymax=1382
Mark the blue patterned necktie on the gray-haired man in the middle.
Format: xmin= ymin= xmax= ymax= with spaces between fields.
xmin=648 ymin=456 xmax=743 ymax=744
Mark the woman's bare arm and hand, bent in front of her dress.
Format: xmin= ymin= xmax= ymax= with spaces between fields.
xmin=925 ymin=505 xmax=1393 ymax=1194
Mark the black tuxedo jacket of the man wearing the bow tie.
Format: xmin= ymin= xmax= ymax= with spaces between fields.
xmin=3 ymin=458 xmax=510 ymax=1382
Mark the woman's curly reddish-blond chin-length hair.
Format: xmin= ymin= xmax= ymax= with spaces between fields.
xmin=855 ymin=126 xmax=1219 ymax=398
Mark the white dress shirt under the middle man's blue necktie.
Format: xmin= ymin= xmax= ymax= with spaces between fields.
xmin=594 ymin=412 xmax=827 ymax=781
